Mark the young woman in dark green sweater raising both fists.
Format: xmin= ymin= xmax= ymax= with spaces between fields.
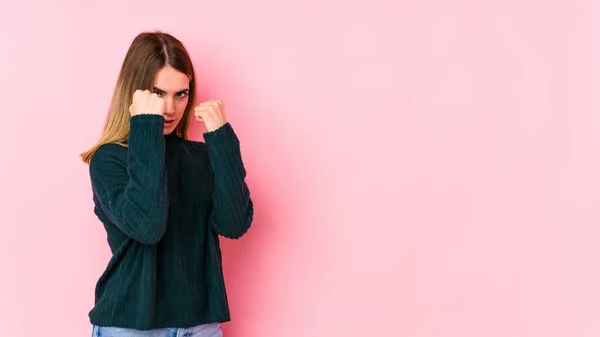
xmin=81 ymin=32 xmax=254 ymax=337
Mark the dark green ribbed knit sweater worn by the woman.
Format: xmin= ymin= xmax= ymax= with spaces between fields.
xmin=89 ymin=115 xmax=254 ymax=330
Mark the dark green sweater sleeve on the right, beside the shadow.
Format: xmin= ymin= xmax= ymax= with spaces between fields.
xmin=204 ymin=123 xmax=254 ymax=239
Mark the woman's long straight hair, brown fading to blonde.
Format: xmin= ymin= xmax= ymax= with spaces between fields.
xmin=80 ymin=31 xmax=196 ymax=164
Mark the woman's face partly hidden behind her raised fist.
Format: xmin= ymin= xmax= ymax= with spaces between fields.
xmin=153 ymin=66 xmax=190 ymax=135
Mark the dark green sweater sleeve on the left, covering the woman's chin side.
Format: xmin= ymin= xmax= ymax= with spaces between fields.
xmin=90 ymin=114 xmax=169 ymax=244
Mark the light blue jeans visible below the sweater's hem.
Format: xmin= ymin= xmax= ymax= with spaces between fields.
xmin=92 ymin=323 xmax=223 ymax=337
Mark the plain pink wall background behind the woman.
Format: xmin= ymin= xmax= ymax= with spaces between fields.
xmin=0 ymin=0 xmax=600 ymax=337
